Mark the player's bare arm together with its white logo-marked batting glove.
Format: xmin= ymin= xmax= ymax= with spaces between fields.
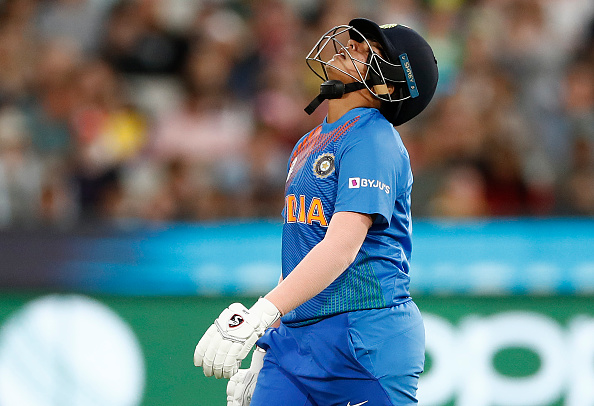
xmin=194 ymin=212 xmax=372 ymax=378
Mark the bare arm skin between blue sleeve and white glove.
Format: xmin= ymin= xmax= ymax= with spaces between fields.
xmin=265 ymin=211 xmax=373 ymax=314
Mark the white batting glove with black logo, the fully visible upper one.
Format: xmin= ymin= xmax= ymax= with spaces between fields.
xmin=194 ymin=298 xmax=281 ymax=379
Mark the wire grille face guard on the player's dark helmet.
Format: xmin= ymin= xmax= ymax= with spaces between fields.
xmin=305 ymin=25 xmax=413 ymax=102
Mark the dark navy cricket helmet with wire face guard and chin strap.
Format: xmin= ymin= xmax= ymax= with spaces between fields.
xmin=306 ymin=18 xmax=438 ymax=125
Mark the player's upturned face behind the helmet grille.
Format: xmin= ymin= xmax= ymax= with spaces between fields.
xmin=326 ymin=39 xmax=381 ymax=83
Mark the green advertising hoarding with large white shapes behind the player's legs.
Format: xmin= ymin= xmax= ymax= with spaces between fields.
xmin=0 ymin=294 xmax=594 ymax=406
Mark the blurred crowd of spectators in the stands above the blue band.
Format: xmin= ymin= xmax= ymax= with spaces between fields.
xmin=0 ymin=0 xmax=594 ymax=228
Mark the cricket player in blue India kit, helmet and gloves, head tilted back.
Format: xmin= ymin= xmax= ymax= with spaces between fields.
xmin=194 ymin=18 xmax=438 ymax=406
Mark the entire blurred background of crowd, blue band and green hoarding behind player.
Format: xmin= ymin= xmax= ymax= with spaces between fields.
xmin=0 ymin=0 xmax=594 ymax=406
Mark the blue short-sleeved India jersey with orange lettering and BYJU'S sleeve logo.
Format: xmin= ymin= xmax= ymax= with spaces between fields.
xmin=282 ymin=108 xmax=413 ymax=326
